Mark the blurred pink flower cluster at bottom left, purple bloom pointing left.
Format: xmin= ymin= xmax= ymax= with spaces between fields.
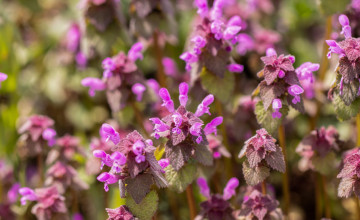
xmin=19 ymin=186 xmax=67 ymax=220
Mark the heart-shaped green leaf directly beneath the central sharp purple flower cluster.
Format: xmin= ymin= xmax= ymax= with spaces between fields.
xmin=164 ymin=163 xmax=197 ymax=193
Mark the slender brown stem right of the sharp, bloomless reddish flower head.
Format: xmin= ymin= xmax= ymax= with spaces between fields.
xmin=279 ymin=125 xmax=290 ymax=216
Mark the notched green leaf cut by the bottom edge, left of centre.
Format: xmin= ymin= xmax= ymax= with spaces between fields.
xmin=126 ymin=190 xmax=159 ymax=220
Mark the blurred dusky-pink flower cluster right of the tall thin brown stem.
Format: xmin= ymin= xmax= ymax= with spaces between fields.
xmin=296 ymin=126 xmax=341 ymax=172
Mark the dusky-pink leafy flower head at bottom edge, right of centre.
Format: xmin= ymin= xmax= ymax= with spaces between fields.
xmin=240 ymin=189 xmax=283 ymax=220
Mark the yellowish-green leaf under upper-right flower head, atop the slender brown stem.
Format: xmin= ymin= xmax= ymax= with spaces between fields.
xmin=255 ymin=101 xmax=289 ymax=134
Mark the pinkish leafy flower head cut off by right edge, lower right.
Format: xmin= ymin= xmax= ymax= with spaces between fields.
xmin=337 ymin=149 xmax=360 ymax=198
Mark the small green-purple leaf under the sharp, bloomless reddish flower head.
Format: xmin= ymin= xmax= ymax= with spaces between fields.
xmin=243 ymin=161 xmax=270 ymax=186
